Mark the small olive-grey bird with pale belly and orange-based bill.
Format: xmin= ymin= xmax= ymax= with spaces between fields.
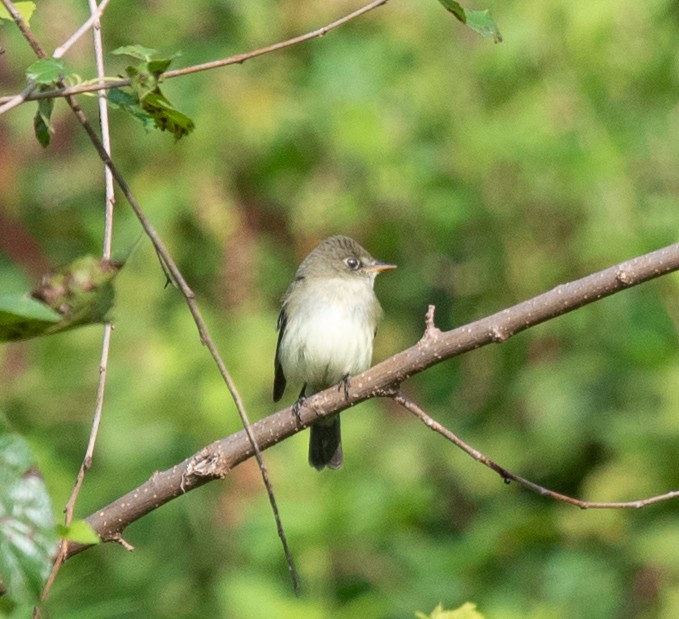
xmin=273 ymin=236 xmax=396 ymax=471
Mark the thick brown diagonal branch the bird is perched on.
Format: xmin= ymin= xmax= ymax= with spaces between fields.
xmin=68 ymin=243 xmax=679 ymax=556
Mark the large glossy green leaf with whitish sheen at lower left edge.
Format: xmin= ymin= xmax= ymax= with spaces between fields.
xmin=0 ymin=431 xmax=58 ymax=604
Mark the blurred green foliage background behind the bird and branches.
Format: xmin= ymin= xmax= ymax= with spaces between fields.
xmin=0 ymin=0 xmax=679 ymax=619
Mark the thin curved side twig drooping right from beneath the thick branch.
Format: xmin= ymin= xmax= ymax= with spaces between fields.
xmin=393 ymin=393 xmax=679 ymax=509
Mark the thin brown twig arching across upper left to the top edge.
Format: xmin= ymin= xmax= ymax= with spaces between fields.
xmin=0 ymin=0 xmax=389 ymax=110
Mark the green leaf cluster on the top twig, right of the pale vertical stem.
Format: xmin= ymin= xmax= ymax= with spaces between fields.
xmin=108 ymin=45 xmax=195 ymax=140
